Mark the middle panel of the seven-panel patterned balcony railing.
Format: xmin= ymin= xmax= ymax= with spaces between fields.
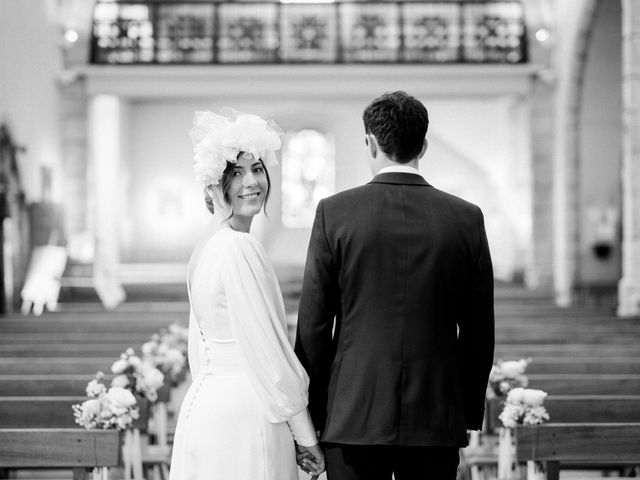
xmin=280 ymin=4 xmax=338 ymax=62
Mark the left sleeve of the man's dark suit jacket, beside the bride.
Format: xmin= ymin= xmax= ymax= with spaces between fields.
xmin=295 ymin=201 xmax=340 ymax=429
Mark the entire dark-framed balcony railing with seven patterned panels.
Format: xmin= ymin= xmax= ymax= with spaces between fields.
xmin=91 ymin=1 xmax=527 ymax=65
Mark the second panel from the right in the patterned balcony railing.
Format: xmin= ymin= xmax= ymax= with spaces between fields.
xmin=402 ymin=3 xmax=460 ymax=63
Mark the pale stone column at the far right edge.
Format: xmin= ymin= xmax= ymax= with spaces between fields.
xmin=618 ymin=0 xmax=640 ymax=316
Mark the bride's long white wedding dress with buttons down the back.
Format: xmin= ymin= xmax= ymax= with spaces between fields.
xmin=170 ymin=226 xmax=317 ymax=480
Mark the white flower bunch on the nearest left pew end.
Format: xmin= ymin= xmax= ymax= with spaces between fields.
xmin=72 ymin=372 xmax=139 ymax=430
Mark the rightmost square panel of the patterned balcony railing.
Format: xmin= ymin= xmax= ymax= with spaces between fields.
xmin=463 ymin=2 xmax=524 ymax=63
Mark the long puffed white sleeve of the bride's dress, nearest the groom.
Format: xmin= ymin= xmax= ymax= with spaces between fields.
xmin=211 ymin=231 xmax=317 ymax=446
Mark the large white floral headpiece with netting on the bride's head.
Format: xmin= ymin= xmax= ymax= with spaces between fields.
xmin=189 ymin=108 xmax=284 ymax=186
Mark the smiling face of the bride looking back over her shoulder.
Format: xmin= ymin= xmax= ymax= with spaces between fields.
xmin=228 ymin=153 xmax=269 ymax=217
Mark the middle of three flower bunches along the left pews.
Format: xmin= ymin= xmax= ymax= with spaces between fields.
xmin=111 ymin=348 xmax=164 ymax=402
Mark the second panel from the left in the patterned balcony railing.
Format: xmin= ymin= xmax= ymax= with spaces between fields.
xmin=157 ymin=4 xmax=214 ymax=63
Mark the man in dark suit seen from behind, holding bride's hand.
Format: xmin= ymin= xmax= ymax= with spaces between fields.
xmin=296 ymin=92 xmax=494 ymax=480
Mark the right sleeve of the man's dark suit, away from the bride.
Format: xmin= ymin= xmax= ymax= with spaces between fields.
xmin=458 ymin=205 xmax=495 ymax=430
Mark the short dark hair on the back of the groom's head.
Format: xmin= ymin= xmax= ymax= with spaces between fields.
xmin=362 ymin=91 xmax=429 ymax=163
